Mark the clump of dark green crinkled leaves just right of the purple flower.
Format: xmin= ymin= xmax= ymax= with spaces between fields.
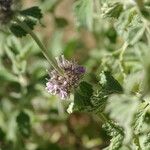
xmin=74 ymin=72 xmax=123 ymax=113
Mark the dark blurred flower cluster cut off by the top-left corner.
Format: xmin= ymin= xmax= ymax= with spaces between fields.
xmin=0 ymin=0 xmax=13 ymax=24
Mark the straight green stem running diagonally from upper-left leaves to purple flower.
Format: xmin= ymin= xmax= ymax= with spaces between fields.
xmin=15 ymin=18 xmax=63 ymax=74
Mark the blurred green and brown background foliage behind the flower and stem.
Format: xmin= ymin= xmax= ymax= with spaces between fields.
xmin=0 ymin=0 xmax=150 ymax=150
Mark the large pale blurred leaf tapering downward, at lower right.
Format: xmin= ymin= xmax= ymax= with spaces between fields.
xmin=105 ymin=94 xmax=139 ymax=141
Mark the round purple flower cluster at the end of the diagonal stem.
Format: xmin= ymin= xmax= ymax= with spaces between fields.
xmin=46 ymin=55 xmax=85 ymax=99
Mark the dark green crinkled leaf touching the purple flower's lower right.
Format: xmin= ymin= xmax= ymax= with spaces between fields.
xmin=73 ymin=82 xmax=108 ymax=114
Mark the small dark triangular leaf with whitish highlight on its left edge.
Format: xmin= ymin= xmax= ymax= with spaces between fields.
xmin=100 ymin=71 xmax=123 ymax=93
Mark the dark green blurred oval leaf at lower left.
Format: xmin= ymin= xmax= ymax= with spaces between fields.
xmin=16 ymin=111 xmax=31 ymax=138
